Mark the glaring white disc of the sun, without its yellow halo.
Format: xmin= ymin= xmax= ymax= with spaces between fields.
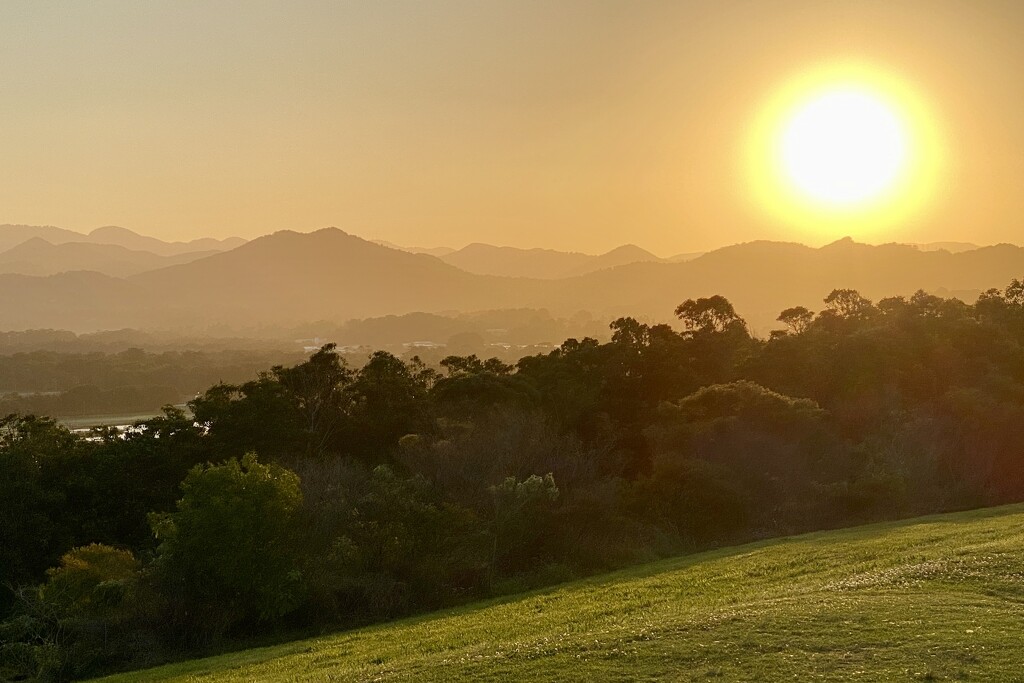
xmin=778 ymin=85 xmax=909 ymax=207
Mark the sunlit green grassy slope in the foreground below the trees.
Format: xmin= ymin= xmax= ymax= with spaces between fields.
xmin=94 ymin=506 xmax=1024 ymax=681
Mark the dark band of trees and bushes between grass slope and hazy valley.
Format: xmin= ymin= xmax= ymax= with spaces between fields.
xmin=0 ymin=281 xmax=1024 ymax=679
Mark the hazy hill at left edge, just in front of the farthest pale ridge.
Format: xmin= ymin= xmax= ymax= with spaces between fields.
xmin=0 ymin=238 xmax=217 ymax=278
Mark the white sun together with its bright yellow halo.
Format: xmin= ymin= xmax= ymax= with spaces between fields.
xmin=748 ymin=65 xmax=943 ymax=239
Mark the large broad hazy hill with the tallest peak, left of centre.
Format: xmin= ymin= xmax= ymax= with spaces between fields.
xmin=130 ymin=227 xmax=542 ymax=323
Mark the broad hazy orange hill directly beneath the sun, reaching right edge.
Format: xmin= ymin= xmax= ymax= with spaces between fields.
xmin=532 ymin=238 xmax=1024 ymax=333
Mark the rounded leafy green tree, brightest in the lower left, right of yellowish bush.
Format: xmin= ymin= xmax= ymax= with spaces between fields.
xmin=150 ymin=453 xmax=302 ymax=639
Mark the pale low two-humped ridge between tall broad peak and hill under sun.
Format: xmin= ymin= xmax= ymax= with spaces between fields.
xmin=440 ymin=243 xmax=662 ymax=280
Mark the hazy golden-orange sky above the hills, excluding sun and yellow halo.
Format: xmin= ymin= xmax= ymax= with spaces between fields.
xmin=0 ymin=0 xmax=1024 ymax=255
